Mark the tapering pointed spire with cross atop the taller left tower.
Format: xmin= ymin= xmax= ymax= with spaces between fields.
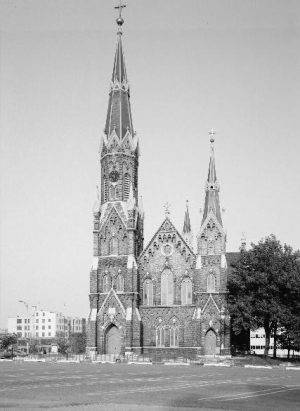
xmin=104 ymin=2 xmax=133 ymax=140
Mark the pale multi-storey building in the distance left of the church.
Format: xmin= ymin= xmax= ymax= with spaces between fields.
xmin=7 ymin=310 xmax=85 ymax=338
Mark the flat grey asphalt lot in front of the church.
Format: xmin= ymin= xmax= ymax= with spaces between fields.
xmin=0 ymin=362 xmax=300 ymax=411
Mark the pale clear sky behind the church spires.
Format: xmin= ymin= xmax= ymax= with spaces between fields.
xmin=0 ymin=0 xmax=300 ymax=328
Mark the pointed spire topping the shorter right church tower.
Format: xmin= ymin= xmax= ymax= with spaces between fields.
xmin=202 ymin=129 xmax=222 ymax=225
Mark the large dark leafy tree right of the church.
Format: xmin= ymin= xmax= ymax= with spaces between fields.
xmin=228 ymin=235 xmax=300 ymax=356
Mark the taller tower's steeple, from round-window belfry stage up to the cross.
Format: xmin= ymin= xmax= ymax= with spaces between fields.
xmin=100 ymin=10 xmax=139 ymax=204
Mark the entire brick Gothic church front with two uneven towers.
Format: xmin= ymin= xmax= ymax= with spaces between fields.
xmin=88 ymin=17 xmax=230 ymax=358
